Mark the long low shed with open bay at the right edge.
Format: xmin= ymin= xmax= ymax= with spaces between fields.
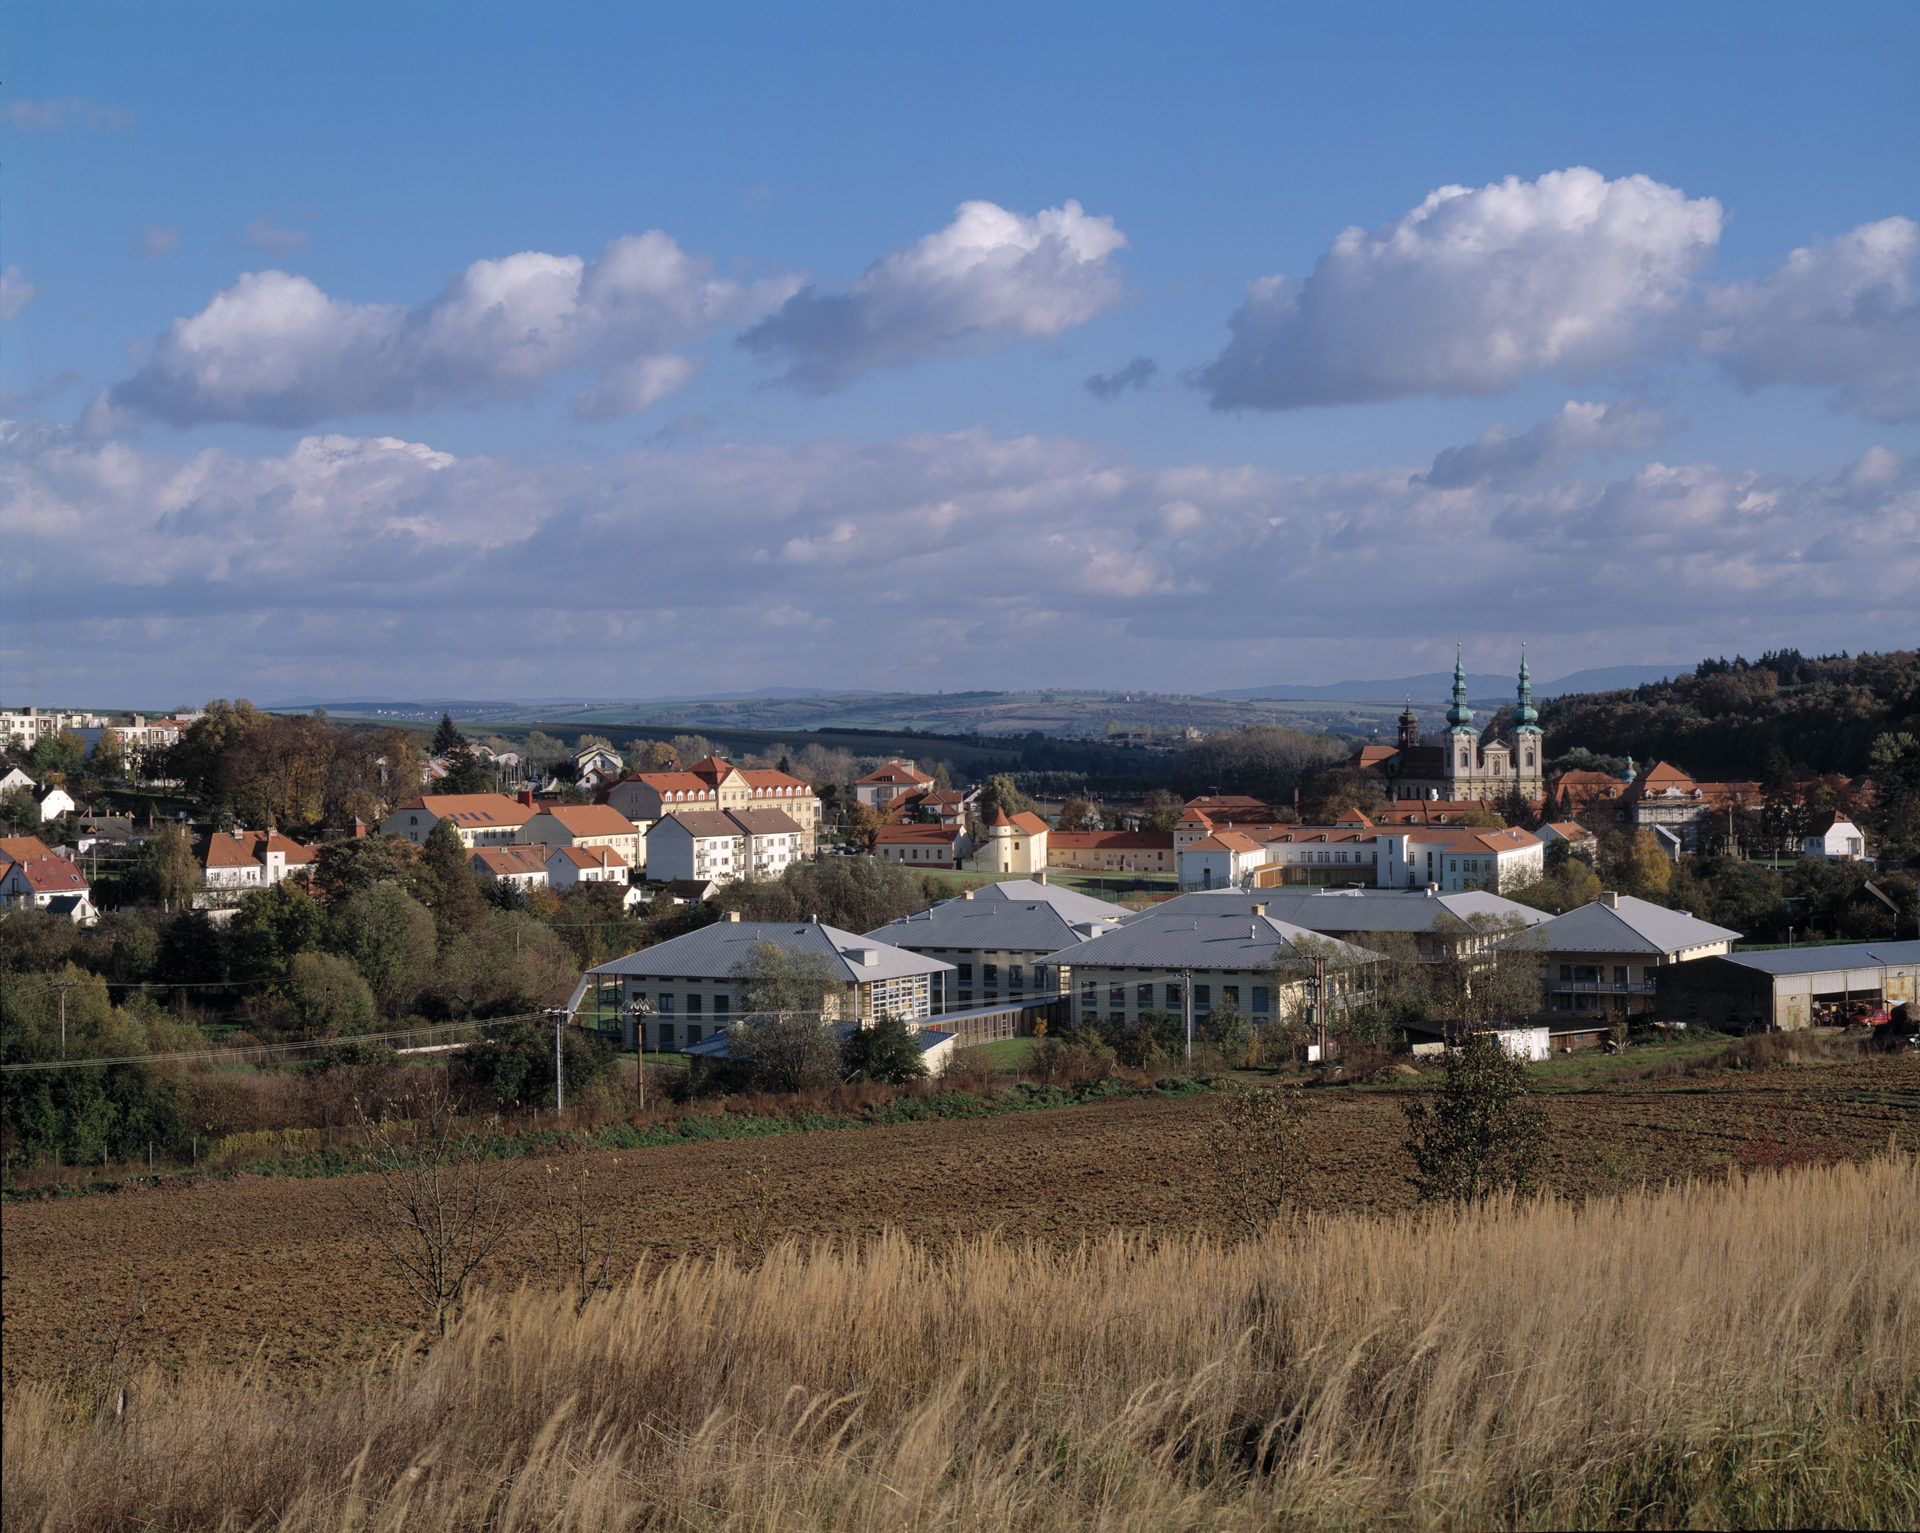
xmin=1653 ymin=941 xmax=1920 ymax=1030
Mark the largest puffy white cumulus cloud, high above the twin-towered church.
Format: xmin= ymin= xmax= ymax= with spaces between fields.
xmin=1198 ymin=165 xmax=1720 ymax=409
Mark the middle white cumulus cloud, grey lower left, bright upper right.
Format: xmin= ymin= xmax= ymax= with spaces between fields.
xmin=739 ymin=200 xmax=1127 ymax=392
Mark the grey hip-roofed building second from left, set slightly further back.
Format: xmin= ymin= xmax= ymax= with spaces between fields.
xmin=868 ymin=872 xmax=1125 ymax=1041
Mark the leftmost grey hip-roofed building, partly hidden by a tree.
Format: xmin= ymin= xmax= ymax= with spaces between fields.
xmin=574 ymin=911 xmax=950 ymax=1051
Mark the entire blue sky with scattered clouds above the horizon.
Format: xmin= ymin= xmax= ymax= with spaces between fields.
xmin=0 ymin=0 xmax=1920 ymax=705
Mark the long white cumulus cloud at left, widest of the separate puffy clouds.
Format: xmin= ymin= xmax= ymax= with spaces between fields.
xmin=105 ymin=231 xmax=793 ymax=426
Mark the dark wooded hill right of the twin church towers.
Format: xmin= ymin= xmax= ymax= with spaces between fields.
xmin=1540 ymin=649 xmax=1920 ymax=780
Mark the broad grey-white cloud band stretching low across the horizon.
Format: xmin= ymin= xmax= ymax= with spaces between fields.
xmin=0 ymin=411 xmax=1920 ymax=697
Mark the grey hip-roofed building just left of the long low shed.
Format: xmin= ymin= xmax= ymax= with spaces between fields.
xmin=1507 ymin=889 xmax=1740 ymax=1022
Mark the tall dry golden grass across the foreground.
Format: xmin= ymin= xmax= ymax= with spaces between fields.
xmin=0 ymin=1156 xmax=1920 ymax=1533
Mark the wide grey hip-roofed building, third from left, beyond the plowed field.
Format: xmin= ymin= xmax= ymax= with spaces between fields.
xmin=1048 ymin=897 xmax=1379 ymax=1028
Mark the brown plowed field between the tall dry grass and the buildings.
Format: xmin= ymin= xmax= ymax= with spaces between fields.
xmin=0 ymin=1059 xmax=1920 ymax=1377
